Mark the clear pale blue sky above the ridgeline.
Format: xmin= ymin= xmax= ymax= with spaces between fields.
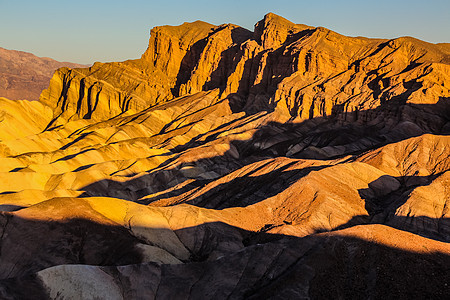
xmin=0 ymin=0 xmax=450 ymax=63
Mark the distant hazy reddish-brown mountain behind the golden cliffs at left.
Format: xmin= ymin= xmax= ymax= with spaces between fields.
xmin=0 ymin=47 xmax=86 ymax=100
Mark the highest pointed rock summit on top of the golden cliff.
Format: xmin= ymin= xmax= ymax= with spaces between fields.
xmin=254 ymin=12 xmax=312 ymax=49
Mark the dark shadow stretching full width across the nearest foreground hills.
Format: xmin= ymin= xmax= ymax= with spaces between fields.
xmin=0 ymin=216 xmax=450 ymax=299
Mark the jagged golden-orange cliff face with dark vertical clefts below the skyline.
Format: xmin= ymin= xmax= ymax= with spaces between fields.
xmin=37 ymin=14 xmax=450 ymax=121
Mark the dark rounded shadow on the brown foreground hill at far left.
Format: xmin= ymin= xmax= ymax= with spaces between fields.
xmin=0 ymin=212 xmax=142 ymax=279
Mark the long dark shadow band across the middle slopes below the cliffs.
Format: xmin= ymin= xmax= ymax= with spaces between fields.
xmin=75 ymin=98 xmax=450 ymax=208
